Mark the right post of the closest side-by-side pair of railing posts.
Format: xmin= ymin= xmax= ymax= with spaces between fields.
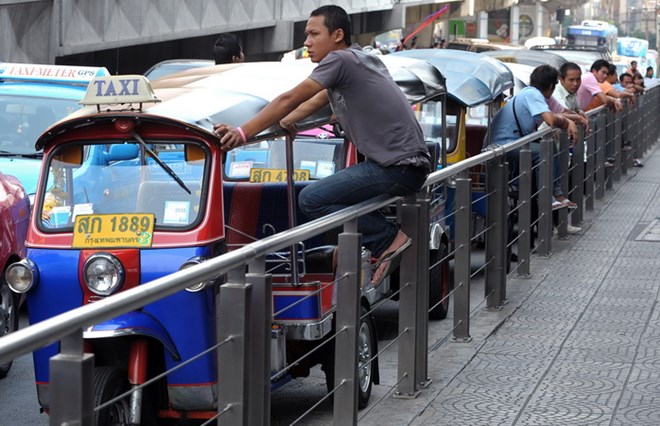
xmin=246 ymin=257 xmax=273 ymax=426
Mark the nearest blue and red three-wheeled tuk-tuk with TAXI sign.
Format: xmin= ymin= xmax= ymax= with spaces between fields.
xmin=6 ymin=55 xmax=444 ymax=425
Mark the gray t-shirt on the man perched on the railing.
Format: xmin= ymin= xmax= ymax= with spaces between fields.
xmin=310 ymin=44 xmax=429 ymax=166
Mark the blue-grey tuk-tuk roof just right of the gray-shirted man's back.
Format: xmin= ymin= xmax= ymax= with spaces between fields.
xmin=390 ymin=49 xmax=513 ymax=107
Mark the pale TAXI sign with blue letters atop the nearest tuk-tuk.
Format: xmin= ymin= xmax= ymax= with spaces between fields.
xmin=80 ymin=74 xmax=160 ymax=105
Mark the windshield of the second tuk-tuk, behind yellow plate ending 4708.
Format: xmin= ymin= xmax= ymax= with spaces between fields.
xmin=224 ymin=134 xmax=344 ymax=182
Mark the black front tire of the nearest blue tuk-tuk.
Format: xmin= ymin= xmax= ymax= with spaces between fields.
xmin=92 ymin=366 xmax=131 ymax=426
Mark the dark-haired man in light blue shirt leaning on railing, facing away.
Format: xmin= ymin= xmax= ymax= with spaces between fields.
xmin=489 ymin=65 xmax=578 ymax=206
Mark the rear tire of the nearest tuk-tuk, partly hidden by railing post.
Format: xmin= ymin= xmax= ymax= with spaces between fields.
xmin=322 ymin=306 xmax=376 ymax=409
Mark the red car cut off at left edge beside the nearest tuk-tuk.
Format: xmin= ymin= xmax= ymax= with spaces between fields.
xmin=0 ymin=173 xmax=30 ymax=378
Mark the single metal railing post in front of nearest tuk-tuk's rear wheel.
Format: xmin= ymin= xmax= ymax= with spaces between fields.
xmin=333 ymin=219 xmax=360 ymax=425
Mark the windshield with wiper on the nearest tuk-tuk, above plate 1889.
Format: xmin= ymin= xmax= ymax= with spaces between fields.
xmin=36 ymin=140 xmax=209 ymax=232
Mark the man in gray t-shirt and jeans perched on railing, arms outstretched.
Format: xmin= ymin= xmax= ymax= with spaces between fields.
xmin=214 ymin=5 xmax=430 ymax=285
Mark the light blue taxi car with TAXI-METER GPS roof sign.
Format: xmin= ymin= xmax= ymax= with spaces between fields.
xmin=0 ymin=63 xmax=109 ymax=195
